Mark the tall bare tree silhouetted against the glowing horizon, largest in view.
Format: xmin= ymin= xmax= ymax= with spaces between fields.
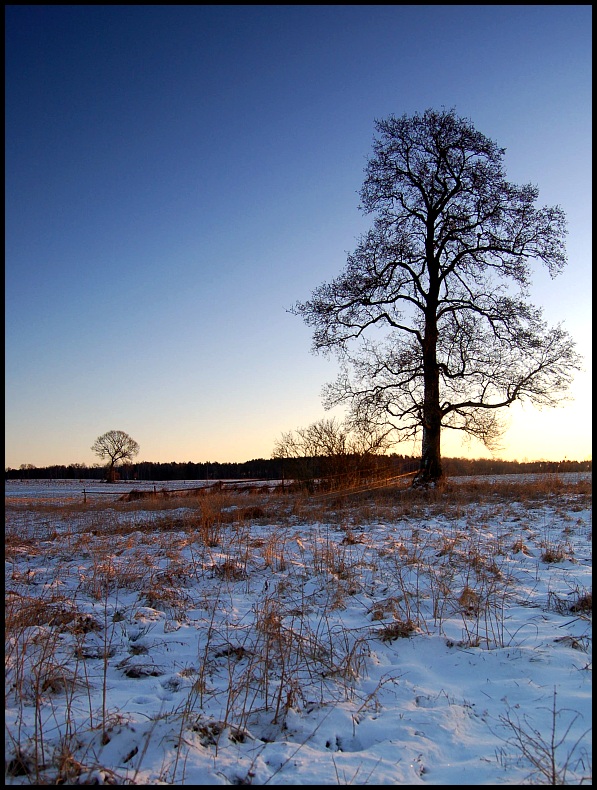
xmin=293 ymin=109 xmax=580 ymax=484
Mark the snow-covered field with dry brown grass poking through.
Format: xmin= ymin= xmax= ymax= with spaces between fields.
xmin=5 ymin=473 xmax=592 ymax=785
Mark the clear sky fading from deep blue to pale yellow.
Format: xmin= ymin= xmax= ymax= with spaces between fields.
xmin=5 ymin=5 xmax=592 ymax=468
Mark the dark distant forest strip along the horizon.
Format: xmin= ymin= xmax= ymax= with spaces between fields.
xmin=5 ymin=454 xmax=593 ymax=482
